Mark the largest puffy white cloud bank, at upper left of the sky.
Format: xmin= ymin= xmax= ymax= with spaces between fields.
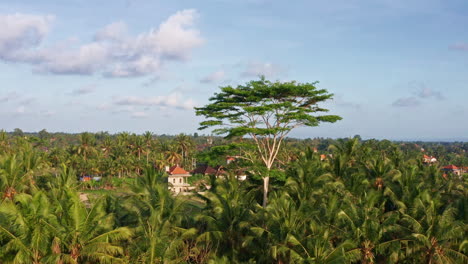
xmin=0 ymin=9 xmax=204 ymax=77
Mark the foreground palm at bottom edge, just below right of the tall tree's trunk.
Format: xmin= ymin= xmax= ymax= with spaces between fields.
xmin=251 ymin=193 xmax=350 ymax=263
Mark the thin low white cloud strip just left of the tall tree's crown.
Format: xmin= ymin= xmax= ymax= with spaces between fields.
xmin=114 ymin=93 xmax=195 ymax=110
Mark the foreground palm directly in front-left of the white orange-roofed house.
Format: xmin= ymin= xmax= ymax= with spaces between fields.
xmin=126 ymin=167 xmax=195 ymax=263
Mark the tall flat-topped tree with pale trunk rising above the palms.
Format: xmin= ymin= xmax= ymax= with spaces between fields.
xmin=195 ymin=77 xmax=341 ymax=207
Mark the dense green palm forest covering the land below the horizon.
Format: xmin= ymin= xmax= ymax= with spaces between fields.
xmin=0 ymin=132 xmax=468 ymax=263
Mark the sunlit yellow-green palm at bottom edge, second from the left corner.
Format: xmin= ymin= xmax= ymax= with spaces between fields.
xmin=52 ymin=189 xmax=132 ymax=263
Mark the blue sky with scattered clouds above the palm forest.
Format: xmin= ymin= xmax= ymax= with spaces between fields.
xmin=0 ymin=0 xmax=468 ymax=140
